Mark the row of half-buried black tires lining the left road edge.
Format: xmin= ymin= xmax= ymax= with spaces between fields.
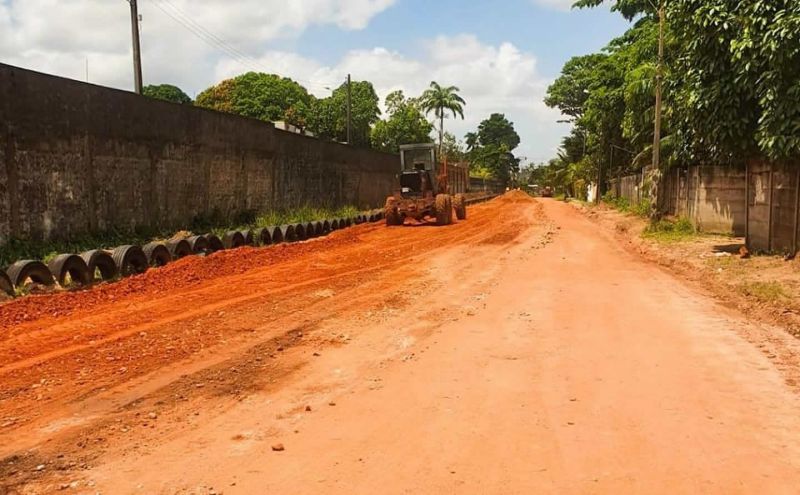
xmin=0 ymin=210 xmax=383 ymax=295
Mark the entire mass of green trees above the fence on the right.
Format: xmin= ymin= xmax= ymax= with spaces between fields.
xmin=539 ymin=0 xmax=800 ymax=203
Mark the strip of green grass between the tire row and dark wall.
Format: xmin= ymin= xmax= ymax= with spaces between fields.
xmin=0 ymin=206 xmax=361 ymax=267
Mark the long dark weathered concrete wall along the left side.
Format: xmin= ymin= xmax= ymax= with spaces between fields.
xmin=0 ymin=64 xmax=400 ymax=244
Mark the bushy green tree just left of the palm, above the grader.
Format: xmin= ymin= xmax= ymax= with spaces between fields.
xmin=370 ymin=91 xmax=433 ymax=153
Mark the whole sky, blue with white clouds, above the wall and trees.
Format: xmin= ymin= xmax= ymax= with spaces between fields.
xmin=0 ymin=0 xmax=627 ymax=161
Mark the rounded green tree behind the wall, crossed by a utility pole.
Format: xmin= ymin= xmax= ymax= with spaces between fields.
xmin=309 ymin=81 xmax=381 ymax=146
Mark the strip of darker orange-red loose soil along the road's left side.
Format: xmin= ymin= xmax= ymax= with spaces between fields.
xmin=0 ymin=200 xmax=548 ymax=446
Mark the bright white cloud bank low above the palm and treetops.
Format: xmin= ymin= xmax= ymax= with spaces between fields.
xmin=223 ymin=35 xmax=567 ymax=161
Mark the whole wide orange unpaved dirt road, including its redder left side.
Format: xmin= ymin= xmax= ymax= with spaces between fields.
xmin=0 ymin=193 xmax=800 ymax=494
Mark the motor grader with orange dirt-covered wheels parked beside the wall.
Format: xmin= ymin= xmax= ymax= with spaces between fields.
xmin=384 ymin=144 xmax=467 ymax=226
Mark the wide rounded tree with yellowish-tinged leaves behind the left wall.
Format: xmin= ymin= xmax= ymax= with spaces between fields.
xmin=195 ymin=72 xmax=314 ymax=124
